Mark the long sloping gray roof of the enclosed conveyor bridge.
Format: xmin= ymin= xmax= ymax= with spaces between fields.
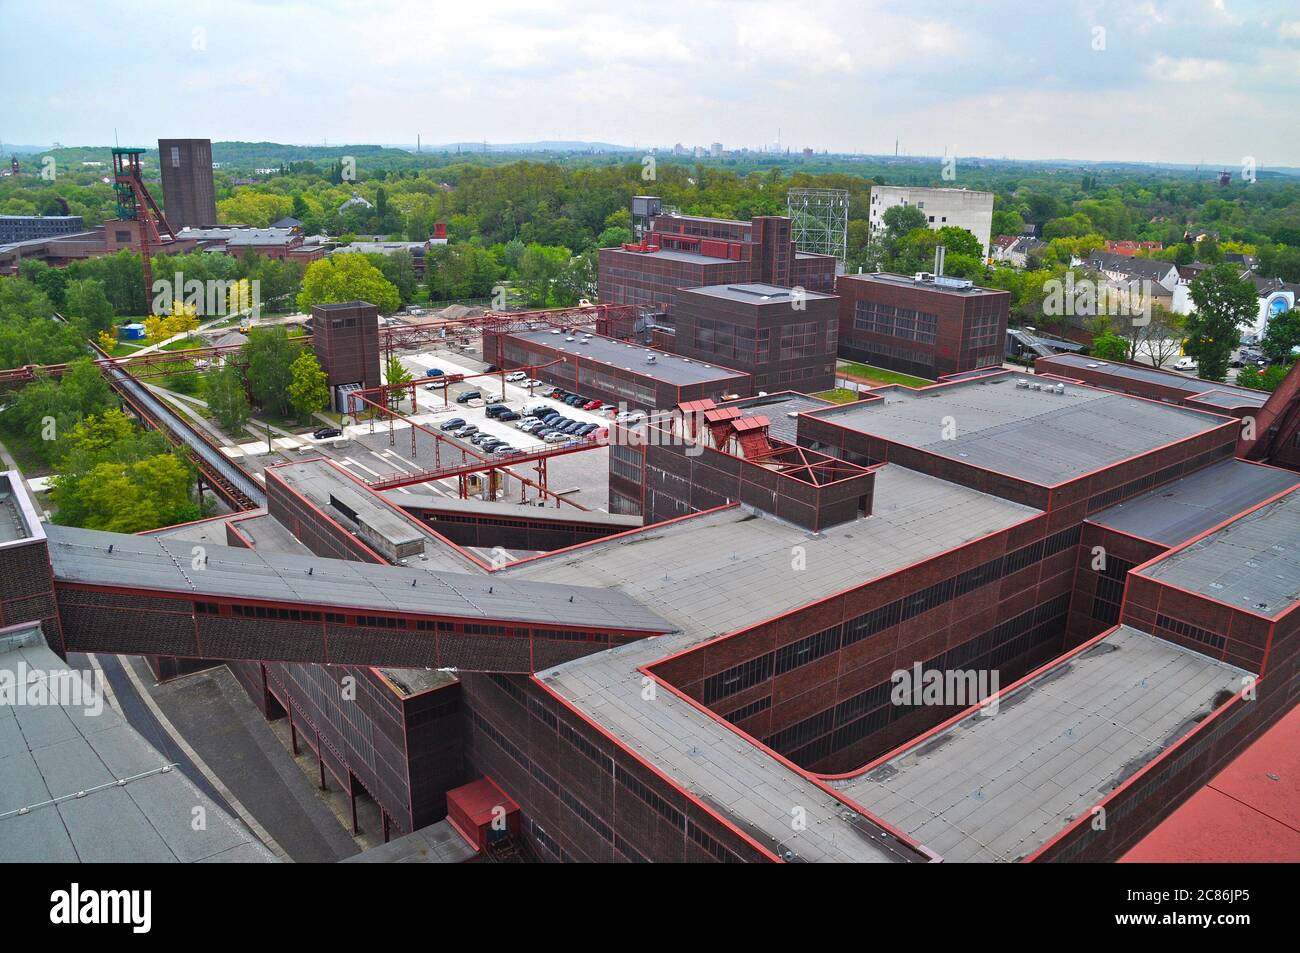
xmin=47 ymin=525 xmax=672 ymax=632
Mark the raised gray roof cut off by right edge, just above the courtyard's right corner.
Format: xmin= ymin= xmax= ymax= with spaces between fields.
xmin=1139 ymin=490 xmax=1300 ymax=613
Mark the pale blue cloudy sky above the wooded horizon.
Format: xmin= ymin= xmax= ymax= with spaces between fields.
xmin=0 ymin=0 xmax=1300 ymax=166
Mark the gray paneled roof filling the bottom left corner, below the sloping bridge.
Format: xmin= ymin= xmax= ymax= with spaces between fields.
xmin=0 ymin=625 xmax=276 ymax=863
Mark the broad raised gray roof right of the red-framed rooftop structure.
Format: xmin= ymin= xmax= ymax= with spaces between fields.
xmin=816 ymin=374 xmax=1227 ymax=486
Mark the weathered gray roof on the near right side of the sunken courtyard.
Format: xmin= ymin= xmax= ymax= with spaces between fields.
xmin=832 ymin=627 xmax=1245 ymax=863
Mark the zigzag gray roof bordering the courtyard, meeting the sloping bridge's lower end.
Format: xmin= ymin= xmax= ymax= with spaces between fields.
xmin=495 ymin=464 xmax=1039 ymax=862
